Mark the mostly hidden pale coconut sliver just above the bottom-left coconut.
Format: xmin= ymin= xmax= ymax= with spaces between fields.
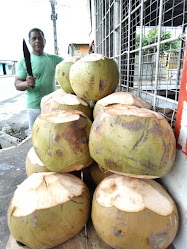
xmin=25 ymin=147 xmax=50 ymax=176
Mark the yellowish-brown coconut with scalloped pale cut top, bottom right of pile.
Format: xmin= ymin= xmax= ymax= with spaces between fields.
xmin=91 ymin=174 xmax=178 ymax=249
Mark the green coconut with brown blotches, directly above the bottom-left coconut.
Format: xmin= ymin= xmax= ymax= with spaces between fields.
xmin=32 ymin=110 xmax=93 ymax=173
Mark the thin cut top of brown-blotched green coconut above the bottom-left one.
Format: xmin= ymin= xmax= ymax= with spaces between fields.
xmin=38 ymin=110 xmax=86 ymax=124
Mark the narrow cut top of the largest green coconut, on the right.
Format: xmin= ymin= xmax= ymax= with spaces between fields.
xmin=104 ymin=104 xmax=164 ymax=119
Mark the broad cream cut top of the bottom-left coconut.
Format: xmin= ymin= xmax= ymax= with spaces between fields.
xmin=11 ymin=172 xmax=84 ymax=217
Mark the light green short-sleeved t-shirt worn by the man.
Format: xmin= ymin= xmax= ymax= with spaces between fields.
xmin=16 ymin=53 xmax=63 ymax=109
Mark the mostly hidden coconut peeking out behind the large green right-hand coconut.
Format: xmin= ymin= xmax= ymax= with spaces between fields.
xmin=93 ymin=92 xmax=152 ymax=119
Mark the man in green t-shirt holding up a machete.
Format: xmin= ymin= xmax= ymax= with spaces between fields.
xmin=14 ymin=28 xmax=63 ymax=130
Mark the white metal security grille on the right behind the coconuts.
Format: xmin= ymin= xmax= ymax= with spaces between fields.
xmin=94 ymin=0 xmax=187 ymax=128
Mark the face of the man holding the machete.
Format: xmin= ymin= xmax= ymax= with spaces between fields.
xmin=29 ymin=31 xmax=45 ymax=54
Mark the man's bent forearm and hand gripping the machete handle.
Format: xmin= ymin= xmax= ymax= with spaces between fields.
xmin=14 ymin=76 xmax=36 ymax=91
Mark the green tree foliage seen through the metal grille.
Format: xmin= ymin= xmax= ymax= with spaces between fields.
xmin=136 ymin=28 xmax=179 ymax=53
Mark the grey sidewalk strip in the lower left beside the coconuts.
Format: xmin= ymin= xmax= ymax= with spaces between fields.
xmin=0 ymin=137 xmax=32 ymax=249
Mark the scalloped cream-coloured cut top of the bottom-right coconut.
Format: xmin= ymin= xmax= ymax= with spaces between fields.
xmin=96 ymin=174 xmax=174 ymax=216
